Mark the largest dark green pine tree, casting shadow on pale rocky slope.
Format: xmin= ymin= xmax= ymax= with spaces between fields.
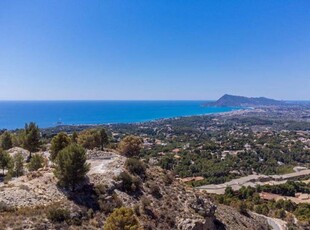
xmin=54 ymin=144 xmax=90 ymax=191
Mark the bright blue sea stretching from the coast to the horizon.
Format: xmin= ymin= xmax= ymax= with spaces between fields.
xmin=0 ymin=101 xmax=241 ymax=129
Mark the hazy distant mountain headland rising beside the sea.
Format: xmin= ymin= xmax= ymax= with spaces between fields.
xmin=205 ymin=94 xmax=286 ymax=107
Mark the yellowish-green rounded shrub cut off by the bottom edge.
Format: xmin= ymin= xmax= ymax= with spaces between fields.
xmin=104 ymin=207 xmax=139 ymax=230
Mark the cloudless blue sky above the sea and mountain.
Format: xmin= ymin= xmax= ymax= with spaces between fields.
xmin=0 ymin=0 xmax=310 ymax=100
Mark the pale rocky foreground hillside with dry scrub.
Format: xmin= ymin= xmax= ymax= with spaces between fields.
xmin=0 ymin=148 xmax=268 ymax=230
